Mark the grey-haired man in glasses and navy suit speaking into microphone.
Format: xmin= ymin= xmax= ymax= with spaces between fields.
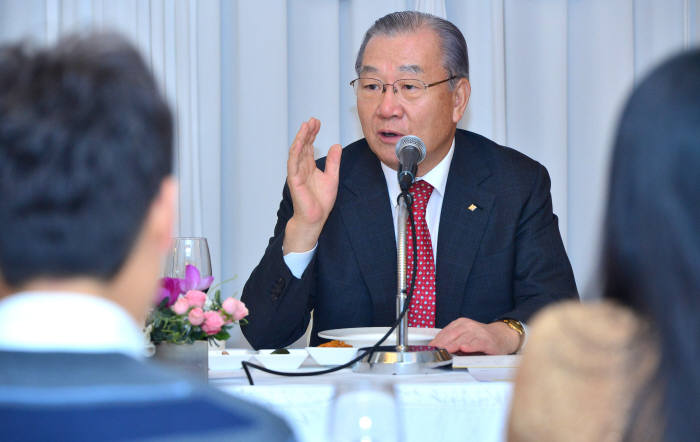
xmin=243 ymin=12 xmax=577 ymax=354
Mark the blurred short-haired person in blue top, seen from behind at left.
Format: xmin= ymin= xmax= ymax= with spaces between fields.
xmin=0 ymin=34 xmax=293 ymax=441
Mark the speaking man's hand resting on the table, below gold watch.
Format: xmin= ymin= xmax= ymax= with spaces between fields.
xmin=430 ymin=318 xmax=520 ymax=355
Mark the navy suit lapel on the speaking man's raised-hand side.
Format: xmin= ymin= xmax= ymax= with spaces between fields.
xmin=339 ymin=147 xmax=397 ymax=325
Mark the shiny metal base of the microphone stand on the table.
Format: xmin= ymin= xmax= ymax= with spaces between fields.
xmin=352 ymin=345 xmax=452 ymax=374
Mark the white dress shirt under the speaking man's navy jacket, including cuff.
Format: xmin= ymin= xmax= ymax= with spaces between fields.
xmin=284 ymin=138 xmax=455 ymax=278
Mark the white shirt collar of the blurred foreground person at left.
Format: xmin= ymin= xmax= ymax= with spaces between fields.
xmin=0 ymin=292 xmax=144 ymax=358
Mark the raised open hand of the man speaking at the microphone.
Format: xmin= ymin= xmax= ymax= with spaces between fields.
xmin=282 ymin=118 xmax=342 ymax=254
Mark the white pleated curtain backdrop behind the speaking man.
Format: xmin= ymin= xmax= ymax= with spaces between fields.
xmin=0 ymin=0 xmax=700 ymax=345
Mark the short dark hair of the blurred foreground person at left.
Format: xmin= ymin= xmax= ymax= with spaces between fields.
xmin=0 ymin=33 xmax=173 ymax=294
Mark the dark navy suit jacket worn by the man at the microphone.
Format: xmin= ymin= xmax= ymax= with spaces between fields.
xmin=242 ymin=130 xmax=578 ymax=348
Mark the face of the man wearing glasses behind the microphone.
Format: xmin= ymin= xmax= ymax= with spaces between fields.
xmin=357 ymin=28 xmax=469 ymax=176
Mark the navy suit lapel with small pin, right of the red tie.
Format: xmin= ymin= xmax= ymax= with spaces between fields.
xmin=435 ymin=132 xmax=494 ymax=327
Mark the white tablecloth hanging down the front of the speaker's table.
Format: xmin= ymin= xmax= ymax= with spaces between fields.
xmin=209 ymin=354 xmax=515 ymax=442
